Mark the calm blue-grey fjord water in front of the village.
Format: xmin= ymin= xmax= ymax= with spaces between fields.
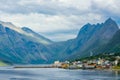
xmin=0 ymin=68 xmax=120 ymax=80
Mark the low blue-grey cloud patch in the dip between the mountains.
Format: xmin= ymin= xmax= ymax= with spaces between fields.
xmin=40 ymin=29 xmax=79 ymax=41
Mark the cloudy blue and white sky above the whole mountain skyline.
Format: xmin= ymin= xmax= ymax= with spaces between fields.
xmin=0 ymin=0 xmax=120 ymax=41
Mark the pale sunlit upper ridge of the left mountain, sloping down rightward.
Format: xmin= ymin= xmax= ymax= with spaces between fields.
xmin=0 ymin=21 xmax=53 ymax=45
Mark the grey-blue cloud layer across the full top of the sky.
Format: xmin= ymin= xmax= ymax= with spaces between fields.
xmin=0 ymin=0 xmax=120 ymax=15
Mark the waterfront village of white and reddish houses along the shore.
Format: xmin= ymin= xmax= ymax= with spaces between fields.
xmin=53 ymin=54 xmax=120 ymax=70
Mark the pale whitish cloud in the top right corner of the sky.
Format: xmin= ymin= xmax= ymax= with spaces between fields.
xmin=93 ymin=0 xmax=120 ymax=15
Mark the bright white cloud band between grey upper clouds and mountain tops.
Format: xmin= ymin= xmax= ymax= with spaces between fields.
xmin=0 ymin=13 xmax=101 ymax=32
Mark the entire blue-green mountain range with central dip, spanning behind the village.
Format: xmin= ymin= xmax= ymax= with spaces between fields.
xmin=0 ymin=18 xmax=120 ymax=64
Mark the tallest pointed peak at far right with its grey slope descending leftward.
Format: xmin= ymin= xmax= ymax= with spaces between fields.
xmin=77 ymin=18 xmax=119 ymax=55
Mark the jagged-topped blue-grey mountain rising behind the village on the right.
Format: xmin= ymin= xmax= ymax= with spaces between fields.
xmin=60 ymin=18 xmax=119 ymax=59
